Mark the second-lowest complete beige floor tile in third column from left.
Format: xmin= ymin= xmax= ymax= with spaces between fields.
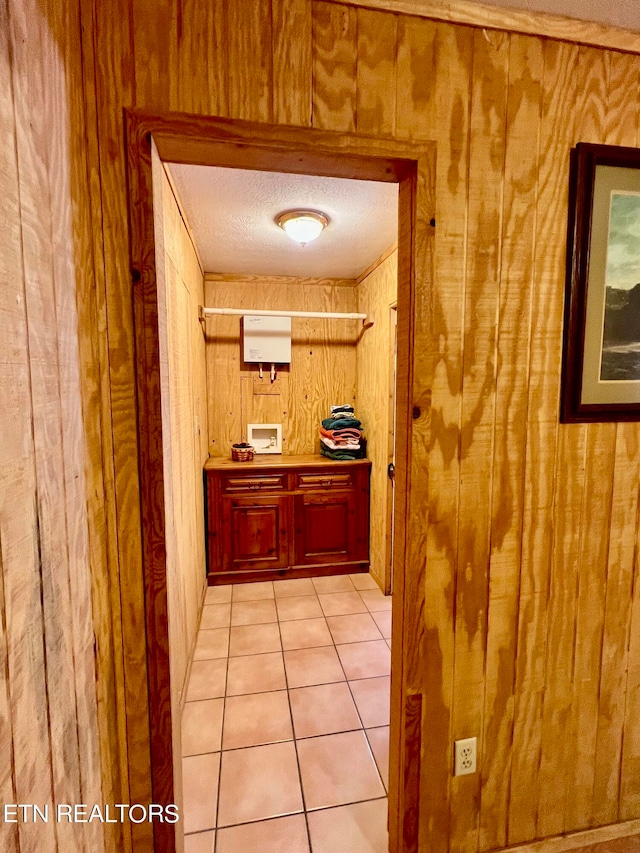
xmin=289 ymin=681 xmax=362 ymax=738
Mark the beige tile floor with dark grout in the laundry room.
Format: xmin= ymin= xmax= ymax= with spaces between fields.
xmin=182 ymin=574 xmax=391 ymax=853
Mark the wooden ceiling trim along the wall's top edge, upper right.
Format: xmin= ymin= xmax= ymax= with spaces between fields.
xmin=323 ymin=0 xmax=640 ymax=53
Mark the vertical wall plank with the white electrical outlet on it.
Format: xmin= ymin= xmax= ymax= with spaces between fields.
xmin=450 ymin=26 xmax=509 ymax=853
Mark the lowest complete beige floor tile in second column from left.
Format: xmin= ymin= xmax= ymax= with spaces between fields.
xmin=218 ymin=741 xmax=302 ymax=826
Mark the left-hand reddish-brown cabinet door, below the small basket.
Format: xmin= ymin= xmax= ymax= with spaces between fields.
xmin=222 ymin=495 xmax=290 ymax=572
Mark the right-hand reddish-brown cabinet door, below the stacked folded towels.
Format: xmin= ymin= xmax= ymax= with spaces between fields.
xmin=294 ymin=491 xmax=357 ymax=566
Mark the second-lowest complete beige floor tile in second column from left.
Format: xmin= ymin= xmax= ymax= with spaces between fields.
xmin=222 ymin=690 xmax=293 ymax=749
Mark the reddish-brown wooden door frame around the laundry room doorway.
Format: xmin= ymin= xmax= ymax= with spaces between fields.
xmin=125 ymin=110 xmax=436 ymax=853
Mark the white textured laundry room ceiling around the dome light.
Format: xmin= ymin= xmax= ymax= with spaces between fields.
xmin=167 ymin=163 xmax=398 ymax=278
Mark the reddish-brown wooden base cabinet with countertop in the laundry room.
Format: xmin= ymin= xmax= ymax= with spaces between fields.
xmin=205 ymin=455 xmax=371 ymax=584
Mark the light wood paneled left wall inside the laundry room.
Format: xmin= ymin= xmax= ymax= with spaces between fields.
xmin=152 ymin=156 xmax=208 ymax=836
